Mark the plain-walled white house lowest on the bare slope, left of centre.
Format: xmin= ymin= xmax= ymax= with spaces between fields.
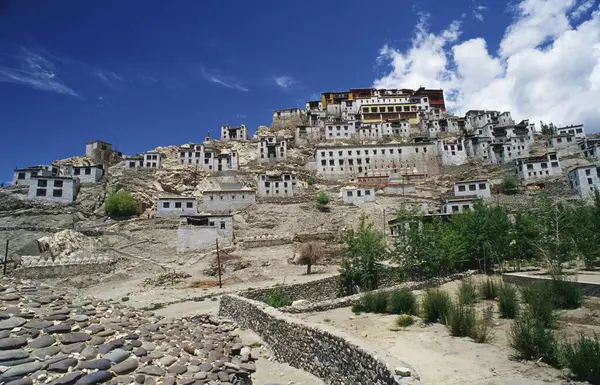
xmin=177 ymin=215 xmax=233 ymax=253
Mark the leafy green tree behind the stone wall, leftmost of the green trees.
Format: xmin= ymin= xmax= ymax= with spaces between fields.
xmin=340 ymin=214 xmax=387 ymax=294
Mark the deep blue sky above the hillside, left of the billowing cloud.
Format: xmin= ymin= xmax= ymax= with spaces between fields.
xmin=0 ymin=0 xmax=600 ymax=180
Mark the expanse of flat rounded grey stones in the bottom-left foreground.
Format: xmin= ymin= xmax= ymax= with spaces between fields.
xmin=0 ymin=278 xmax=255 ymax=385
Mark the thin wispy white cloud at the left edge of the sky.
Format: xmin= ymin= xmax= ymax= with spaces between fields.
xmin=0 ymin=48 xmax=79 ymax=97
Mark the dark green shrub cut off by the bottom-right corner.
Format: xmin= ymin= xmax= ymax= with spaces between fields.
xmin=562 ymin=334 xmax=600 ymax=384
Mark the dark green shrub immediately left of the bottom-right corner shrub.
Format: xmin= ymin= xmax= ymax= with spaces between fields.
xmin=509 ymin=314 xmax=560 ymax=366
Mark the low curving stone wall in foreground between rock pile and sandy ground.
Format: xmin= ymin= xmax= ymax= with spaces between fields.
xmin=219 ymin=295 xmax=420 ymax=385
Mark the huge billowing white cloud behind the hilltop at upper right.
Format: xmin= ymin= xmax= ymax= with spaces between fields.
xmin=374 ymin=0 xmax=600 ymax=132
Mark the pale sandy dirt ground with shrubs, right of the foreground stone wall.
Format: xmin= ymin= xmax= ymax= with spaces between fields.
xmin=297 ymin=276 xmax=600 ymax=385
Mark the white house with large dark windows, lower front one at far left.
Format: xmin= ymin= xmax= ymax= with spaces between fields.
xmin=27 ymin=176 xmax=79 ymax=203
